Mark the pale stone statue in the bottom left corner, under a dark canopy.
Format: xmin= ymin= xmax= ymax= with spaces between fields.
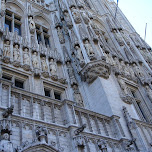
xmin=0 ymin=133 xmax=14 ymax=152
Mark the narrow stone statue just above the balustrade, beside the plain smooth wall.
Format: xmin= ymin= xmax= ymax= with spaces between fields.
xmin=73 ymin=85 xmax=84 ymax=107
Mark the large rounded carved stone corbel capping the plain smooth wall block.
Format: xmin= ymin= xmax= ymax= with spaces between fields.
xmin=80 ymin=60 xmax=111 ymax=83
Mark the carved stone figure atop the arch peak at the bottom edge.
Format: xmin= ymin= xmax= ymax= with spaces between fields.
xmin=36 ymin=126 xmax=48 ymax=144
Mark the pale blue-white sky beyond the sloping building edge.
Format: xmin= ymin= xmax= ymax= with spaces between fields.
xmin=114 ymin=0 xmax=152 ymax=47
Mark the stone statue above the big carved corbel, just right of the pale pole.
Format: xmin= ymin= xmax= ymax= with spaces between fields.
xmin=84 ymin=40 xmax=95 ymax=59
